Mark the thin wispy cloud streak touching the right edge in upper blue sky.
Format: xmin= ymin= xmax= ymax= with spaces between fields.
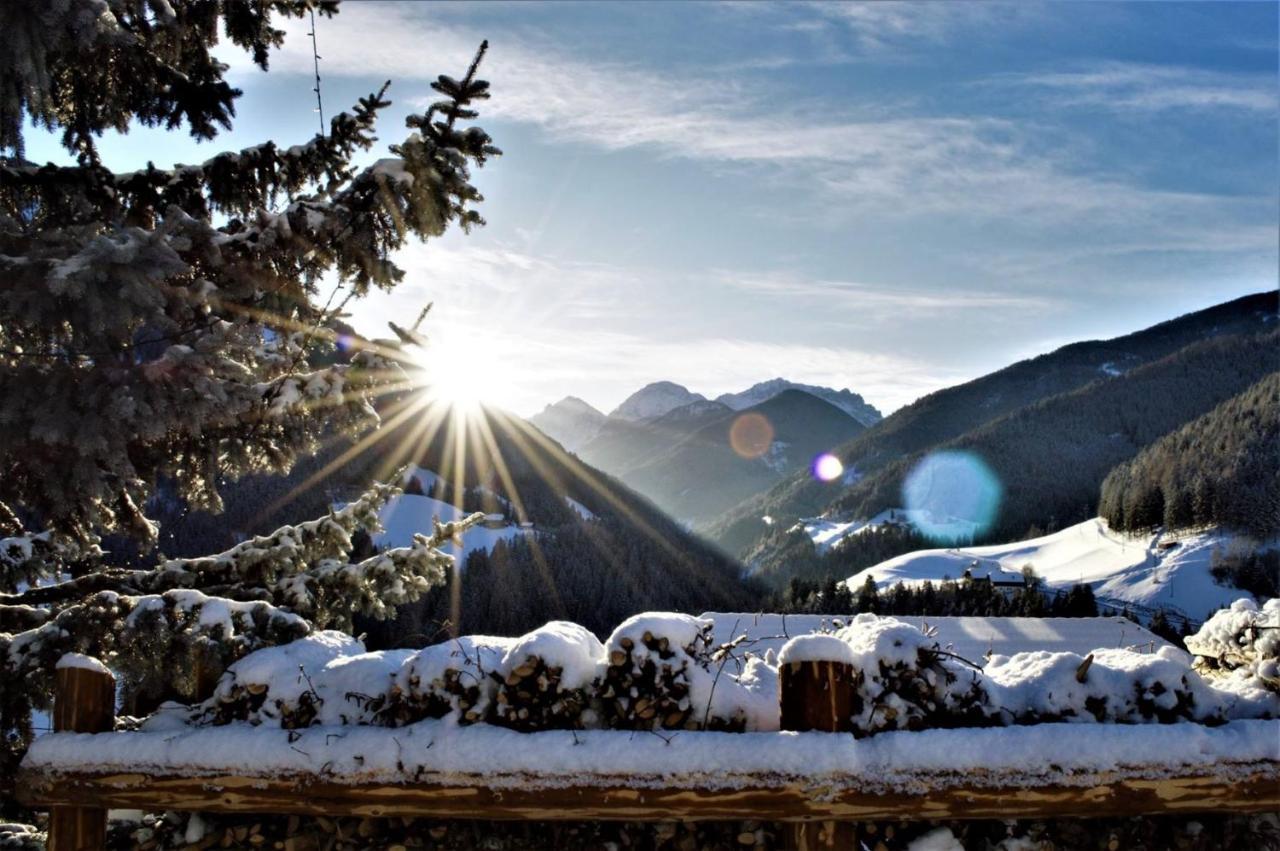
xmin=988 ymin=61 xmax=1280 ymax=114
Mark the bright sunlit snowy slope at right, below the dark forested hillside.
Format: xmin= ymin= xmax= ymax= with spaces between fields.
xmin=846 ymin=518 xmax=1245 ymax=621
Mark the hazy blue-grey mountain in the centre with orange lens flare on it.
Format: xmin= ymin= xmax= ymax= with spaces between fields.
xmin=618 ymin=390 xmax=863 ymax=523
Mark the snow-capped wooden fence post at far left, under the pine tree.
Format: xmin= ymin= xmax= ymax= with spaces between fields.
xmin=49 ymin=665 xmax=115 ymax=851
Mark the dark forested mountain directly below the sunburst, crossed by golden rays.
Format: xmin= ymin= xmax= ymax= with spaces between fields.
xmin=148 ymin=398 xmax=763 ymax=646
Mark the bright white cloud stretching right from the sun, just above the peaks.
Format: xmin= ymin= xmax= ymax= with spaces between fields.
xmin=352 ymin=237 xmax=978 ymax=415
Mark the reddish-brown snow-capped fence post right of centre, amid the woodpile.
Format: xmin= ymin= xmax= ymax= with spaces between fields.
xmin=778 ymin=662 xmax=856 ymax=851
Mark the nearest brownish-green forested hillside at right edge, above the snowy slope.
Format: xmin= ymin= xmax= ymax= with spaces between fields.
xmin=1098 ymin=373 xmax=1280 ymax=537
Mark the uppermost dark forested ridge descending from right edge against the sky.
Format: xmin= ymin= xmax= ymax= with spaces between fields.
xmin=705 ymin=292 xmax=1277 ymax=557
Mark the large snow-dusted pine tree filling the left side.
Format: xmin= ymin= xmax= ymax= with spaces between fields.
xmin=0 ymin=0 xmax=500 ymax=815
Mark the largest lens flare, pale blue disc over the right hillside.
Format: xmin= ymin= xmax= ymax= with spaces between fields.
xmin=902 ymin=452 xmax=1004 ymax=543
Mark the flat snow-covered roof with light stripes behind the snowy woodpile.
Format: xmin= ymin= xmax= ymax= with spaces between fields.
xmin=701 ymin=612 xmax=1170 ymax=664
